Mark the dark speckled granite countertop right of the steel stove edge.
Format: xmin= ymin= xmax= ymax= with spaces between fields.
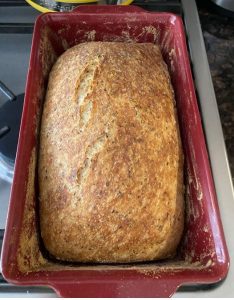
xmin=199 ymin=4 xmax=234 ymax=183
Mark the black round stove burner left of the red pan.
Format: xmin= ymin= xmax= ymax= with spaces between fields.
xmin=0 ymin=82 xmax=24 ymax=182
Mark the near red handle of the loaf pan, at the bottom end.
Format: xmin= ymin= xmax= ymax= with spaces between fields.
xmin=52 ymin=278 xmax=181 ymax=298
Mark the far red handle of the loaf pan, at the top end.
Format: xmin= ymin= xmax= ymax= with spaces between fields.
xmin=72 ymin=5 xmax=148 ymax=14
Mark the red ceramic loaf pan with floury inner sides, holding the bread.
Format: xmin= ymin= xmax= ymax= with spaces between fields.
xmin=2 ymin=6 xmax=229 ymax=297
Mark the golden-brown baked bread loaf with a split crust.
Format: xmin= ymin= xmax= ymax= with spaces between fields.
xmin=39 ymin=42 xmax=184 ymax=262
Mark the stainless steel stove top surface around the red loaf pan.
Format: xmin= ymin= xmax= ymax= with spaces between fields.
xmin=0 ymin=0 xmax=234 ymax=297
